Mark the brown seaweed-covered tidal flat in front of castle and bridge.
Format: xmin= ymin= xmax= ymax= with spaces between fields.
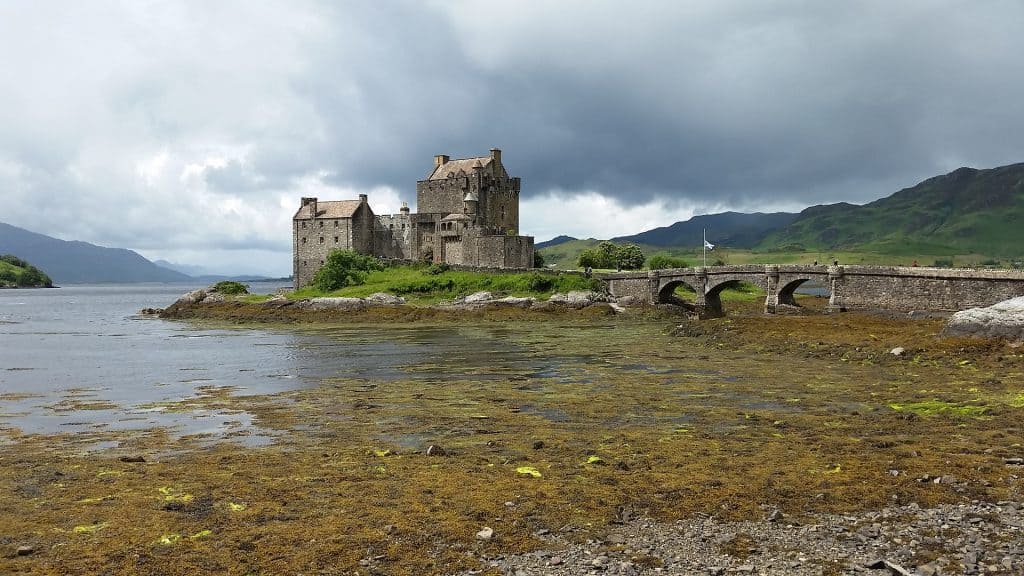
xmin=0 ymin=298 xmax=1024 ymax=574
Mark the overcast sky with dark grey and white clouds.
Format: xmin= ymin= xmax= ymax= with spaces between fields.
xmin=0 ymin=0 xmax=1024 ymax=276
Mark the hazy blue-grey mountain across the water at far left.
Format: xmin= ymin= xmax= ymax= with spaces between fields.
xmin=0 ymin=222 xmax=194 ymax=284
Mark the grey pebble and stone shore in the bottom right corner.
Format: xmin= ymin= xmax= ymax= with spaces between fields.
xmin=454 ymin=496 xmax=1024 ymax=576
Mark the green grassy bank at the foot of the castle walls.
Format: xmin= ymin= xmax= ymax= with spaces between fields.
xmin=289 ymin=266 xmax=601 ymax=304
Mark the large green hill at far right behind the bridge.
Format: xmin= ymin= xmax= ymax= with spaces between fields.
xmin=758 ymin=163 xmax=1024 ymax=257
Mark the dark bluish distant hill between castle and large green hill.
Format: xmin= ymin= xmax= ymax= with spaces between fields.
xmin=611 ymin=212 xmax=797 ymax=248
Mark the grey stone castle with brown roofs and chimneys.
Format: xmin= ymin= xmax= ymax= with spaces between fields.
xmin=292 ymin=149 xmax=534 ymax=289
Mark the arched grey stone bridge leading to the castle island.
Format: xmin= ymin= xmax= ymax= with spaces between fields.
xmin=600 ymin=264 xmax=1024 ymax=317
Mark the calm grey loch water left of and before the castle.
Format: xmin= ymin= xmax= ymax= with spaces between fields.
xmin=0 ymin=283 xmax=557 ymax=444
